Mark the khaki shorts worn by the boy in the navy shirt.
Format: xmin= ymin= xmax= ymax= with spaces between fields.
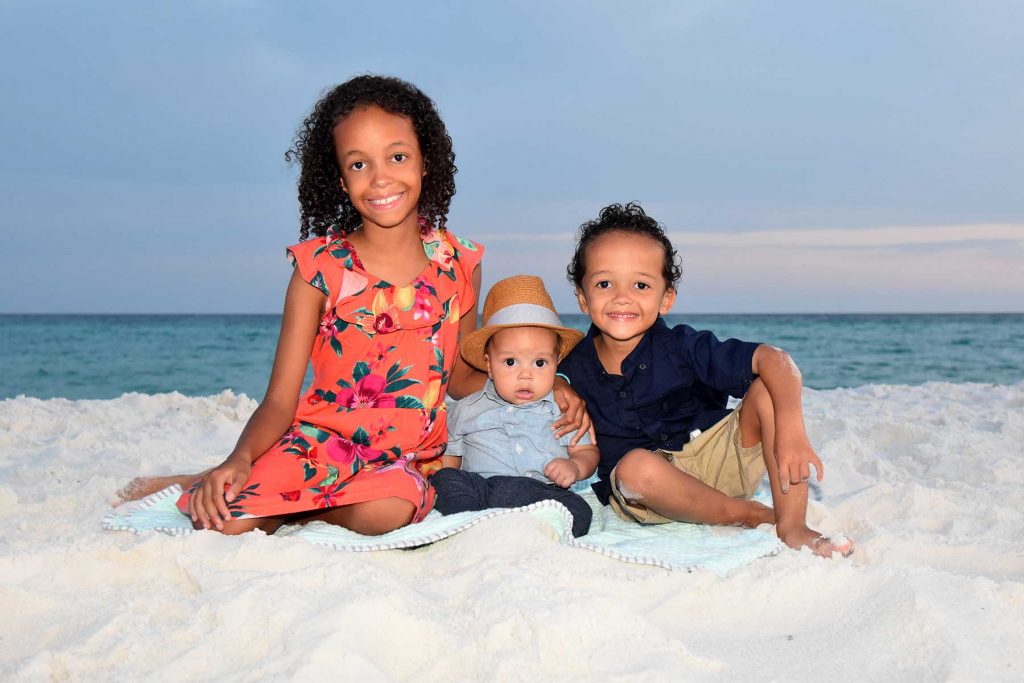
xmin=608 ymin=407 xmax=766 ymax=524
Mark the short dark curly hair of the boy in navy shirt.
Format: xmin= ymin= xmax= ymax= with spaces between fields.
xmin=565 ymin=202 xmax=683 ymax=292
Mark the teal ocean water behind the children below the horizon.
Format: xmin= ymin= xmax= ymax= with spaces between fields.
xmin=0 ymin=313 xmax=1024 ymax=399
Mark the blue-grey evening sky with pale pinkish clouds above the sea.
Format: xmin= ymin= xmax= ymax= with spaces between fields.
xmin=0 ymin=0 xmax=1024 ymax=313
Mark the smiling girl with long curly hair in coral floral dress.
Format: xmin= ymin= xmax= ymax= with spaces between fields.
xmin=121 ymin=76 xmax=585 ymax=535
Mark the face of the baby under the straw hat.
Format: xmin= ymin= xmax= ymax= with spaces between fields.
xmin=483 ymin=328 xmax=558 ymax=405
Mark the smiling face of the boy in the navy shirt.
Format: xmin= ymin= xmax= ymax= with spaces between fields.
xmin=577 ymin=231 xmax=676 ymax=346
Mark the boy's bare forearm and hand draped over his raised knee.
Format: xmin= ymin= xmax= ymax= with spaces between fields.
xmin=752 ymin=344 xmax=824 ymax=494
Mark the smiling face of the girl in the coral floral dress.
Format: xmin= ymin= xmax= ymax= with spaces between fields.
xmin=334 ymin=105 xmax=426 ymax=235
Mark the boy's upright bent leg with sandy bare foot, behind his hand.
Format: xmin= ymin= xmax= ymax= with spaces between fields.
xmin=739 ymin=379 xmax=853 ymax=557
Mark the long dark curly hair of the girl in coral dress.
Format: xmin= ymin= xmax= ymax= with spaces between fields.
xmin=285 ymin=75 xmax=458 ymax=240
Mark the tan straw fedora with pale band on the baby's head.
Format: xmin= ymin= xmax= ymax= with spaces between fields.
xmin=460 ymin=275 xmax=583 ymax=372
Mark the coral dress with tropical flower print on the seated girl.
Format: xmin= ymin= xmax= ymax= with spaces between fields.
xmin=178 ymin=230 xmax=483 ymax=521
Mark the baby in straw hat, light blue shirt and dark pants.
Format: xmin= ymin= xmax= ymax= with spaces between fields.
xmin=430 ymin=275 xmax=599 ymax=537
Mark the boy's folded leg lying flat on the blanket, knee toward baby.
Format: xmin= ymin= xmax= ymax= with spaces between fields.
xmin=612 ymin=449 xmax=775 ymax=528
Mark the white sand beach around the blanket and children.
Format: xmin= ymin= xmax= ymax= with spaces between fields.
xmin=0 ymin=383 xmax=1024 ymax=681
